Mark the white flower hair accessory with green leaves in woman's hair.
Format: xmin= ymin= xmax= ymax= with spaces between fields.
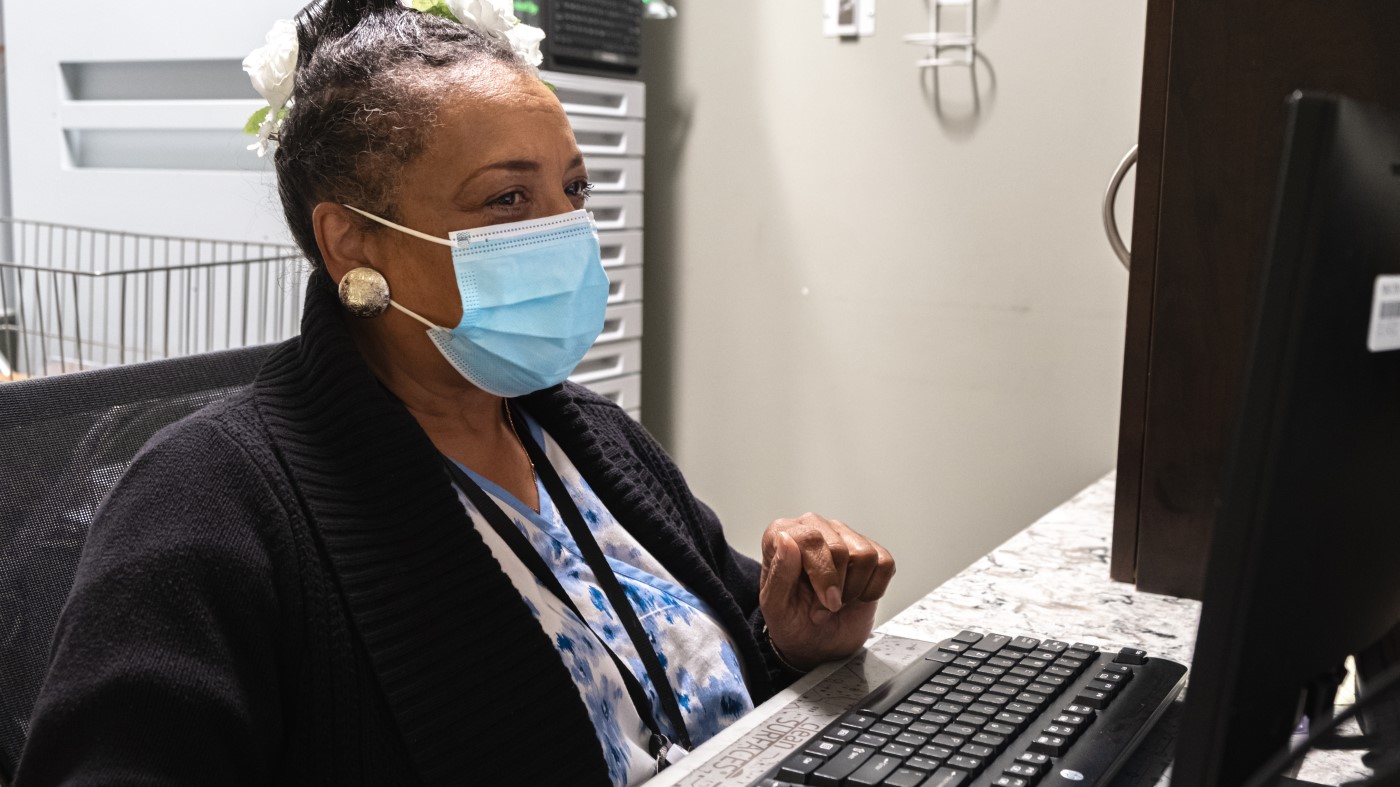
xmin=244 ymin=0 xmax=553 ymax=157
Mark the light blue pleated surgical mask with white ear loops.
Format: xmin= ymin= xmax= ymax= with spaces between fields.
xmin=346 ymin=204 xmax=608 ymax=396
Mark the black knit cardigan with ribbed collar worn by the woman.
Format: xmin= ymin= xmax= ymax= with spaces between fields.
xmin=17 ymin=273 xmax=795 ymax=787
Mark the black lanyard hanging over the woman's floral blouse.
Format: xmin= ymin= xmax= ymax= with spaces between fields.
xmin=442 ymin=410 xmax=692 ymax=756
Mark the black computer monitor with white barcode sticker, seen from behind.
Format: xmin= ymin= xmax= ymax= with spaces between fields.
xmin=1172 ymin=94 xmax=1400 ymax=787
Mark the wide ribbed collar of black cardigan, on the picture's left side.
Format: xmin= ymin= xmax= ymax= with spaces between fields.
xmin=255 ymin=270 xmax=608 ymax=783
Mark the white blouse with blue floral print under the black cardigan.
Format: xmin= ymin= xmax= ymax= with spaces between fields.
xmin=458 ymin=417 xmax=753 ymax=787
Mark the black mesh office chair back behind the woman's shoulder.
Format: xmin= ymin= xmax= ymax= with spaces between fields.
xmin=0 ymin=344 xmax=272 ymax=784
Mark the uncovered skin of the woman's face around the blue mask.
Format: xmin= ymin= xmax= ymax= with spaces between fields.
xmin=365 ymin=70 xmax=588 ymax=328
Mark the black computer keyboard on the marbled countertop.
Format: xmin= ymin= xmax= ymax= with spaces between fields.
xmin=753 ymin=632 xmax=1186 ymax=787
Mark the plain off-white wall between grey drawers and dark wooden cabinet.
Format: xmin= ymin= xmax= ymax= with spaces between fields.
xmin=644 ymin=0 xmax=1145 ymax=616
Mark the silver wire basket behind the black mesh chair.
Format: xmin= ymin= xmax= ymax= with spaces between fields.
xmin=0 ymin=218 xmax=305 ymax=379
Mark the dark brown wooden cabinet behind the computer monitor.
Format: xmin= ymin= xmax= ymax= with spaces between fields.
xmin=1112 ymin=0 xmax=1400 ymax=598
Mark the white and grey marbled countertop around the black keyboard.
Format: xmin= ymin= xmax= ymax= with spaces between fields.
xmin=647 ymin=473 xmax=1369 ymax=787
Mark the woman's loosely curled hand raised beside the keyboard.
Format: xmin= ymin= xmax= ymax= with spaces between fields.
xmin=759 ymin=514 xmax=895 ymax=669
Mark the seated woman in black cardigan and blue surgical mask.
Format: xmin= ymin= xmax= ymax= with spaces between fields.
xmin=18 ymin=0 xmax=893 ymax=787
